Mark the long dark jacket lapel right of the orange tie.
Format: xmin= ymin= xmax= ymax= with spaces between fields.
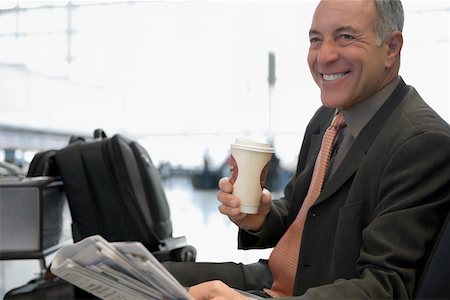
xmin=314 ymin=80 xmax=409 ymax=205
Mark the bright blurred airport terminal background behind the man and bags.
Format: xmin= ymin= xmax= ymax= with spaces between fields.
xmin=0 ymin=0 xmax=450 ymax=299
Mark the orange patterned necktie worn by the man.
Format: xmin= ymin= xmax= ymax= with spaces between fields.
xmin=264 ymin=112 xmax=345 ymax=297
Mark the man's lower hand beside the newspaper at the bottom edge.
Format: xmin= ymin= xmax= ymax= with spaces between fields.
xmin=189 ymin=280 xmax=248 ymax=300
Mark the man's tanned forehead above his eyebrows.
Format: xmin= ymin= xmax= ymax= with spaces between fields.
xmin=311 ymin=0 xmax=377 ymax=29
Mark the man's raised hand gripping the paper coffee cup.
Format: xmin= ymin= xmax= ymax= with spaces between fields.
xmin=217 ymin=177 xmax=272 ymax=231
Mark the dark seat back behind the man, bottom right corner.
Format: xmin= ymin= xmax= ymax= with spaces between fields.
xmin=414 ymin=214 xmax=450 ymax=299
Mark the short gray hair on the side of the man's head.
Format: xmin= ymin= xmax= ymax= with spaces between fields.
xmin=375 ymin=0 xmax=405 ymax=46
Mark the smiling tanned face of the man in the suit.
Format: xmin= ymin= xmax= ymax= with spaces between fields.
xmin=308 ymin=0 xmax=388 ymax=109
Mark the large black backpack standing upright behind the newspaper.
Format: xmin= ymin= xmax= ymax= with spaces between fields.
xmin=55 ymin=130 xmax=196 ymax=261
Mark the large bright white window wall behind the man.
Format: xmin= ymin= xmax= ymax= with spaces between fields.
xmin=0 ymin=0 xmax=450 ymax=170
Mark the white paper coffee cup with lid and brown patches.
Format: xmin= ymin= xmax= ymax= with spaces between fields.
xmin=230 ymin=138 xmax=274 ymax=214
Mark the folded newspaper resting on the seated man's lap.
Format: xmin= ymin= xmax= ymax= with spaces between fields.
xmin=51 ymin=235 xmax=193 ymax=300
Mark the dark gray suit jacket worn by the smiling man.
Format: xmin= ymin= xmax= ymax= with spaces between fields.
xmin=239 ymin=80 xmax=450 ymax=299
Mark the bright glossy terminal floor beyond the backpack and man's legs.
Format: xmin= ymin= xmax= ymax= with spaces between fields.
xmin=0 ymin=178 xmax=271 ymax=299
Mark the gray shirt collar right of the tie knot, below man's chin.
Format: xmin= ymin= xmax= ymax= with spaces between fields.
xmin=343 ymin=76 xmax=400 ymax=139
